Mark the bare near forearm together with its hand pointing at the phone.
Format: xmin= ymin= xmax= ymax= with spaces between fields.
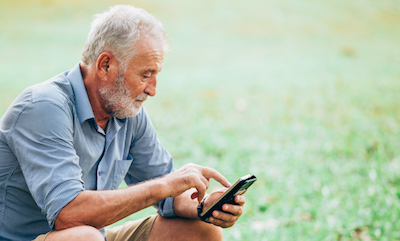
xmin=55 ymin=164 xmax=229 ymax=230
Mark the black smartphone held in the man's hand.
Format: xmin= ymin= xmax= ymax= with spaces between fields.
xmin=199 ymin=174 xmax=257 ymax=221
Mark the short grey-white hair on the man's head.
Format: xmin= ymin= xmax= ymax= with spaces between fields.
xmin=81 ymin=5 xmax=170 ymax=71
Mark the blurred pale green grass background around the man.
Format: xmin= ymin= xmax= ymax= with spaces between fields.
xmin=0 ymin=0 xmax=400 ymax=241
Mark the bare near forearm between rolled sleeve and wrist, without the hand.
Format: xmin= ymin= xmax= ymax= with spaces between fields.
xmin=55 ymin=179 xmax=168 ymax=230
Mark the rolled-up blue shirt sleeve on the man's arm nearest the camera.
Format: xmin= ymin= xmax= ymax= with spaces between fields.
xmin=7 ymin=100 xmax=84 ymax=229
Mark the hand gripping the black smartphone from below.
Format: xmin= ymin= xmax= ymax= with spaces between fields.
xmin=203 ymin=188 xmax=246 ymax=228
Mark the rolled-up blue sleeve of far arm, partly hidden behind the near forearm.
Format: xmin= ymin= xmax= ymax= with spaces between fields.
xmin=125 ymin=107 xmax=175 ymax=217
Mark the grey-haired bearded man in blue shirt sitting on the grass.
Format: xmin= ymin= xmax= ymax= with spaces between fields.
xmin=0 ymin=3 xmax=245 ymax=241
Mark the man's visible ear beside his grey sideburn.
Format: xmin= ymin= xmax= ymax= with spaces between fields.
xmin=96 ymin=52 xmax=118 ymax=81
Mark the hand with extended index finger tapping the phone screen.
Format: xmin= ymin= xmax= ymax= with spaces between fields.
xmin=164 ymin=164 xmax=231 ymax=202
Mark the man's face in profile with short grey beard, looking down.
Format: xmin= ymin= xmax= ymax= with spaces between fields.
xmin=99 ymin=39 xmax=164 ymax=119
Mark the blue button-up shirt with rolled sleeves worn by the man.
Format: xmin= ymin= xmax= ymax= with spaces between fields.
xmin=0 ymin=64 xmax=174 ymax=240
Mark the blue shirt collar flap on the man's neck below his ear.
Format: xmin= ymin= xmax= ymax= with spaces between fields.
xmin=67 ymin=63 xmax=94 ymax=125
